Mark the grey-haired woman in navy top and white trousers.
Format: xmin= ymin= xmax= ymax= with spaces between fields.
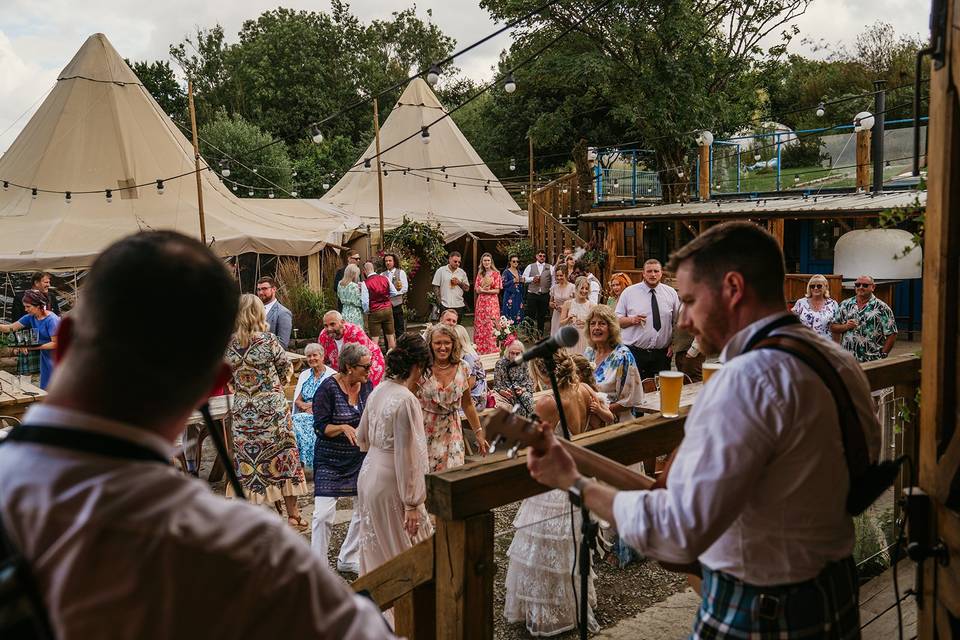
xmin=311 ymin=343 xmax=373 ymax=573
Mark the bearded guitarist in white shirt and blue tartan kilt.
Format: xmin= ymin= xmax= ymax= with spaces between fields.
xmin=528 ymin=222 xmax=880 ymax=638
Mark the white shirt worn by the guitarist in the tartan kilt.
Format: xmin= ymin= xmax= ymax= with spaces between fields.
xmin=613 ymin=313 xmax=880 ymax=585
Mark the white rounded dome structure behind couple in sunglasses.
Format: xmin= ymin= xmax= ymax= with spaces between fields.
xmin=833 ymin=229 xmax=923 ymax=280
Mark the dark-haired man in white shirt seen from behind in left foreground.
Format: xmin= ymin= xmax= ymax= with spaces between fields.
xmin=0 ymin=231 xmax=393 ymax=640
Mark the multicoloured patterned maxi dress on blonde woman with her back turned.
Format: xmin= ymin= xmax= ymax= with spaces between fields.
xmin=226 ymin=332 xmax=307 ymax=504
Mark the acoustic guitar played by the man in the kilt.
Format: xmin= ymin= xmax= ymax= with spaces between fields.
xmin=480 ymin=409 xmax=701 ymax=594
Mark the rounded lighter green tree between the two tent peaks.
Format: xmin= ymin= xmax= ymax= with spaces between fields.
xmin=199 ymin=108 xmax=294 ymax=198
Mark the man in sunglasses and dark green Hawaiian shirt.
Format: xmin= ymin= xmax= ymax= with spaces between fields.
xmin=830 ymin=276 xmax=897 ymax=362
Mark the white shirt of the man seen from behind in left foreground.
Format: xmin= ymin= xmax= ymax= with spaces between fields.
xmin=0 ymin=404 xmax=393 ymax=640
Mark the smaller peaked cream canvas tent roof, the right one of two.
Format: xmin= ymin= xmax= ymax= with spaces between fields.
xmin=321 ymin=78 xmax=527 ymax=241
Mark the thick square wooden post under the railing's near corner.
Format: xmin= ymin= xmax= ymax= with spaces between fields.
xmin=434 ymin=511 xmax=497 ymax=640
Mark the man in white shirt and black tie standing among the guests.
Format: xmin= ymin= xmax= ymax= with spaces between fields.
xmin=616 ymin=259 xmax=680 ymax=378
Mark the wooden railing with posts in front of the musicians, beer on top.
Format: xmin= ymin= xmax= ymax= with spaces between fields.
xmin=353 ymin=355 xmax=920 ymax=640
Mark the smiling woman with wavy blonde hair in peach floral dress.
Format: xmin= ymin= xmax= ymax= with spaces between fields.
xmin=417 ymin=324 xmax=488 ymax=473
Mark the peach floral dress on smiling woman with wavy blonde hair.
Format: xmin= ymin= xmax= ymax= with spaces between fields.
xmin=419 ymin=360 xmax=470 ymax=473
